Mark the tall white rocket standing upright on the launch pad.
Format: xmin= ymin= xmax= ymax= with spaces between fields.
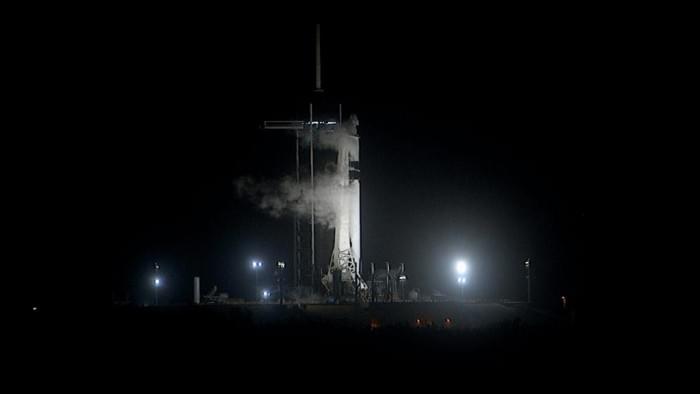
xmin=322 ymin=115 xmax=368 ymax=299
